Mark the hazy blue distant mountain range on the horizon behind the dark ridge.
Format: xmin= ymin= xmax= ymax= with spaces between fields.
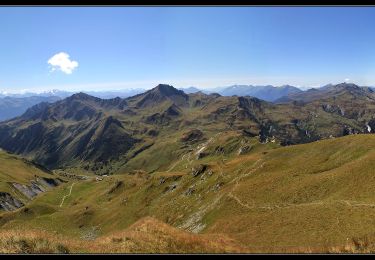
xmin=0 ymin=83 xmax=374 ymax=121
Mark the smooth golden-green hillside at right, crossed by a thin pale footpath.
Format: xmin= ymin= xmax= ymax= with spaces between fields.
xmin=207 ymin=135 xmax=375 ymax=250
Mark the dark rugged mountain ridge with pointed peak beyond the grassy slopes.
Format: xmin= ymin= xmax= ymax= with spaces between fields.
xmin=0 ymin=84 xmax=375 ymax=173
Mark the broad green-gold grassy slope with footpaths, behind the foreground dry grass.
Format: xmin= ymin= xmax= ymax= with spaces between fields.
xmin=0 ymin=133 xmax=375 ymax=252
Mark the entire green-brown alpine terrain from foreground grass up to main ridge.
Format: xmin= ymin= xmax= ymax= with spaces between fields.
xmin=0 ymin=83 xmax=375 ymax=253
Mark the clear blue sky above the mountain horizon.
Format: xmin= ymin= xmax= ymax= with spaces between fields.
xmin=0 ymin=7 xmax=375 ymax=91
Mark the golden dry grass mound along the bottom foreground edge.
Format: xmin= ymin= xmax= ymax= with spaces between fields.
xmin=0 ymin=217 xmax=246 ymax=254
